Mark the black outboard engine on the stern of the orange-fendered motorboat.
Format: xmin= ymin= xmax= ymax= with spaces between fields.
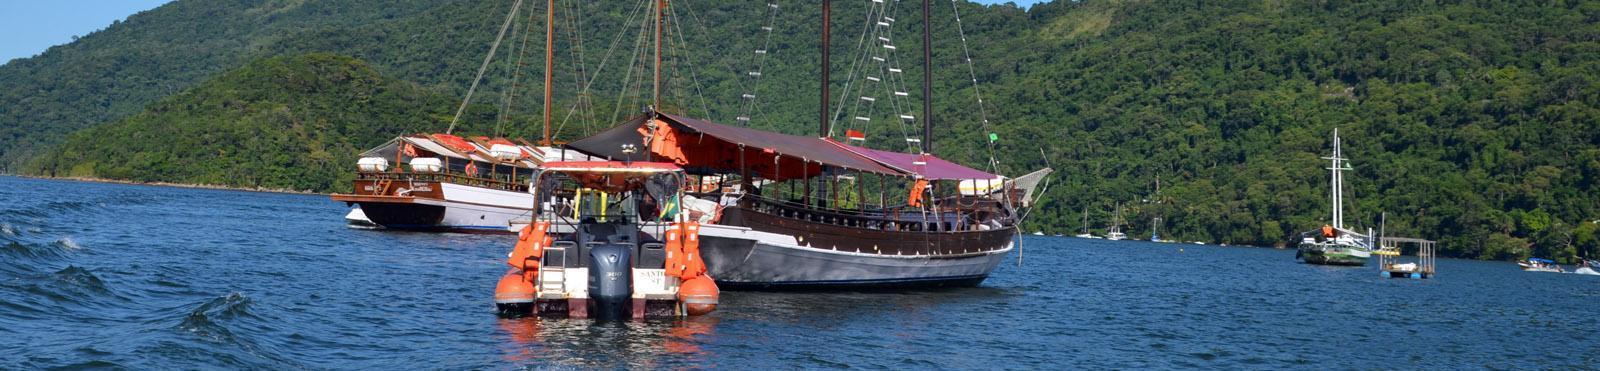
xmin=589 ymin=243 xmax=634 ymax=320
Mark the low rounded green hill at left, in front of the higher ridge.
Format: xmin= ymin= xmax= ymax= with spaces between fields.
xmin=30 ymin=54 xmax=473 ymax=192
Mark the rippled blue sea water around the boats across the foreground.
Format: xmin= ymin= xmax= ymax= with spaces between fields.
xmin=0 ymin=178 xmax=1600 ymax=369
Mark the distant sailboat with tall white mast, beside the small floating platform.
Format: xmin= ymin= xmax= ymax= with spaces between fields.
xmin=1294 ymin=130 xmax=1374 ymax=267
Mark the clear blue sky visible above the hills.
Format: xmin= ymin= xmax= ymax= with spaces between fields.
xmin=0 ymin=0 xmax=1042 ymax=64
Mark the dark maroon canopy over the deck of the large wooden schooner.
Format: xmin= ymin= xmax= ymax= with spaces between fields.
xmin=566 ymin=114 xmax=914 ymax=181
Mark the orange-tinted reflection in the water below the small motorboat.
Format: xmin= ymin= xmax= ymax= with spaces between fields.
xmin=499 ymin=317 xmax=720 ymax=368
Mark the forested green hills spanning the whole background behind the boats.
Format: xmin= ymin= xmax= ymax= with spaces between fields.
xmin=0 ymin=0 xmax=1600 ymax=259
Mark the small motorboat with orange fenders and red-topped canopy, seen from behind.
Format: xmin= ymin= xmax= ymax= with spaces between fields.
xmin=494 ymin=162 xmax=717 ymax=320
